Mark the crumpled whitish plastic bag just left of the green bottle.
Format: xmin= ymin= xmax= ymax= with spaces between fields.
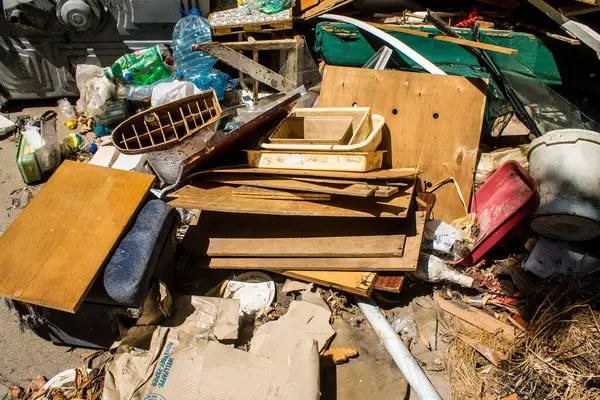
xmin=75 ymin=64 xmax=116 ymax=118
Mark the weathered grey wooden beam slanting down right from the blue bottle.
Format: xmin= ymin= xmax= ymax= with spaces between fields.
xmin=192 ymin=42 xmax=296 ymax=93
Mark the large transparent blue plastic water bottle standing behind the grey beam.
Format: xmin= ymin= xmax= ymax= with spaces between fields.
xmin=173 ymin=8 xmax=217 ymax=90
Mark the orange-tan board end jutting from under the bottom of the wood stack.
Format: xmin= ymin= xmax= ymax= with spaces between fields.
xmin=282 ymin=271 xmax=377 ymax=297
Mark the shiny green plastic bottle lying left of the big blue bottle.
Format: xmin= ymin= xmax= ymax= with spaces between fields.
xmin=104 ymin=44 xmax=173 ymax=85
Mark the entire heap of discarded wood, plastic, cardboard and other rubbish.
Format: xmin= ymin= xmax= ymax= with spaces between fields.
xmin=0 ymin=0 xmax=600 ymax=400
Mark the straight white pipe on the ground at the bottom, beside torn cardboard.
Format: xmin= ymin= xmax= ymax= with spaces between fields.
xmin=356 ymin=297 xmax=442 ymax=400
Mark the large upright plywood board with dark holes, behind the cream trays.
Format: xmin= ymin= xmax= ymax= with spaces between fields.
xmin=319 ymin=66 xmax=487 ymax=222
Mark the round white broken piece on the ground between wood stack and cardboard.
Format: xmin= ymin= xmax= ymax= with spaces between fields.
xmin=223 ymin=271 xmax=275 ymax=315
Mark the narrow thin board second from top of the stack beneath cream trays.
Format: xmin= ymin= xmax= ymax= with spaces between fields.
xmin=202 ymin=172 xmax=377 ymax=197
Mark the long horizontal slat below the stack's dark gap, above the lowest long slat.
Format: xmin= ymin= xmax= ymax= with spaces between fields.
xmin=206 ymin=235 xmax=406 ymax=257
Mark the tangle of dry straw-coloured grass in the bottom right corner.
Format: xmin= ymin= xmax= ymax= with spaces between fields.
xmin=446 ymin=277 xmax=600 ymax=400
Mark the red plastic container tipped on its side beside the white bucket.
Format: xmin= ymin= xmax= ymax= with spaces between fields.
xmin=457 ymin=161 xmax=540 ymax=266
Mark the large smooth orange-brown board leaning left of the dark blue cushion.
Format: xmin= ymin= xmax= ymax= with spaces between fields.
xmin=0 ymin=161 xmax=154 ymax=313
